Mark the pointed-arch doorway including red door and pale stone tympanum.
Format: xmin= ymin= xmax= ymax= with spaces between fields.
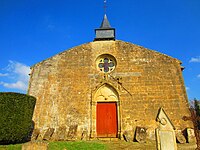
xmin=94 ymin=84 xmax=119 ymax=138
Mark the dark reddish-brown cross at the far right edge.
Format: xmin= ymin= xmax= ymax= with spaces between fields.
xmin=183 ymin=109 xmax=200 ymax=150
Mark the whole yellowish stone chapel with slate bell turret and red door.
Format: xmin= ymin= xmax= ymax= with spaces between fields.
xmin=28 ymin=15 xmax=193 ymax=140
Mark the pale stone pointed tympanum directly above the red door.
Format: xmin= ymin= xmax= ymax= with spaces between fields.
xmin=94 ymin=84 xmax=118 ymax=102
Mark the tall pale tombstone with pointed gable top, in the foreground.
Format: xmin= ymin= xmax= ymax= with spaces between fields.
xmin=156 ymin=108 xmax=177 ymax=150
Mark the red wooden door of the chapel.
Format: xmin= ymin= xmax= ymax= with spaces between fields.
xmin=96 ymin=103 xmax=117 ymax=137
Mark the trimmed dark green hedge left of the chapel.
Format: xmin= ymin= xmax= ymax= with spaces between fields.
xmin=0 ymin=92 xmax=36 ymax=144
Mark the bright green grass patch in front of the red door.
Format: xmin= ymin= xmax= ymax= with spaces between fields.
xmin=49 ymin=141 xmax=107 ymax=150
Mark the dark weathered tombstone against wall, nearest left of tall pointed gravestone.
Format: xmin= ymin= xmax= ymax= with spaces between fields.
xmin=135 ymin=127 xmax=147 ymax=143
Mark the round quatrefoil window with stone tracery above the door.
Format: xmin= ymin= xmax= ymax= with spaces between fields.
xmin=96 ymin=54 xmax=116 ymax=73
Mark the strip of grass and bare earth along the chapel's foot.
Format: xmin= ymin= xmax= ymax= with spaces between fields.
xmin=0 ymin=140 xmax=196 ymax=150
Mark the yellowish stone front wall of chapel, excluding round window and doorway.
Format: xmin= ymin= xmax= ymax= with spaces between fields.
xmin=29 ymin=41 xmax=192 ymax=139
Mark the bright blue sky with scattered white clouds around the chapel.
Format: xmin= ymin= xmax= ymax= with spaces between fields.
xmin=0 ymin=0 xmax=200 ymax=99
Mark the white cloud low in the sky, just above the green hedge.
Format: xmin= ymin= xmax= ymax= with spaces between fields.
xmin=0 ymin=60 xmax=30 ymax=91
